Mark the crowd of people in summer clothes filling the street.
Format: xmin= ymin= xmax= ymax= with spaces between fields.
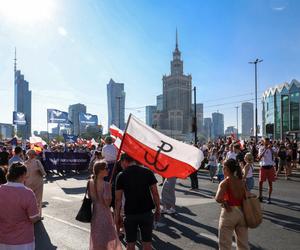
xmin=0 ymin=137 xmax=299 ymax=250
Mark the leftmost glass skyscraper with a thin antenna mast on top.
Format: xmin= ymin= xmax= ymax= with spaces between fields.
xmin=14 ymin=50 xmax=31 ymax=139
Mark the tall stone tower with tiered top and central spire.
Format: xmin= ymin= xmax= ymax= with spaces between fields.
xmin=153 ymin=31 xmax=192 ymax=140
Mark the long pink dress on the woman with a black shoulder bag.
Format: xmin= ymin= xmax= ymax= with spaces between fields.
xmin=89 ymin=181 xmax=122 ymax=250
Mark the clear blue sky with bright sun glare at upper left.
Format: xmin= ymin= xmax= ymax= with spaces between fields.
xmin=0 ymin=0 xmax=300 ymax=133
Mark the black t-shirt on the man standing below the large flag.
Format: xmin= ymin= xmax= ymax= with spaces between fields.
xmin=116 ymin=165 xmax=157 ymax=215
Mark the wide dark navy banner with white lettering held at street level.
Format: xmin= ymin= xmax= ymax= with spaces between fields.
xmin=44 ymin=152 xmax=90 ymax=170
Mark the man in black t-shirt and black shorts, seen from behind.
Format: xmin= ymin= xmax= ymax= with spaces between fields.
xmin=115 ymin=154 xmax=160 ymax=250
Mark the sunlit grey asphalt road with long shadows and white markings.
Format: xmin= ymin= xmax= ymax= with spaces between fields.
xmin=35 ymin=171 xmax=300 ymax=250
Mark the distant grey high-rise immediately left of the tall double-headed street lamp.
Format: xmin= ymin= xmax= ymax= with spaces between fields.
xmin=242 ymin=102 xmax=255 ymax=139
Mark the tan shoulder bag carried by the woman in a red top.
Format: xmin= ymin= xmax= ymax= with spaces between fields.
xmin=242 ymin=194 xmax=262 ymax=228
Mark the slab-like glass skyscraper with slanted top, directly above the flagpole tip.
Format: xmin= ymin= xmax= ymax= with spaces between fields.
xmin=107 ymin=79 xmax=125 ymax=130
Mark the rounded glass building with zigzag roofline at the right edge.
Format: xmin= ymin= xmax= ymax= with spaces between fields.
xmin=262 ymin=79 xmax=300 ymax=140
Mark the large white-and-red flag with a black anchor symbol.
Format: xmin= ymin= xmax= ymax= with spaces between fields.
xmin=121 ymin=115 xmax=204 ymax=179
